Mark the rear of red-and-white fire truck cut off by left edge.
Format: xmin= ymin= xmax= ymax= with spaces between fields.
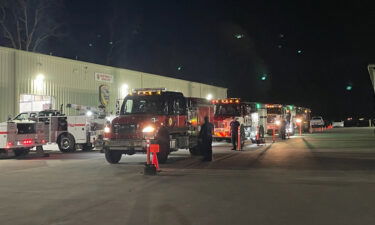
xmin=0 ymin=121 xmax=46 ymax=156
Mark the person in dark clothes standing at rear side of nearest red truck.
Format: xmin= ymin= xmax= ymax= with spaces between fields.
xmin=199 ymin=116 xmax=214 ymax=161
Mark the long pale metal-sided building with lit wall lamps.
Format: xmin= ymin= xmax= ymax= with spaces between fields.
xmin=0 ymin=47 xmax=227 ymax=121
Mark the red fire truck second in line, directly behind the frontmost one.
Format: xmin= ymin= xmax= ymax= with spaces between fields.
xmin=212 ymin=98 xmax=252 ymax=146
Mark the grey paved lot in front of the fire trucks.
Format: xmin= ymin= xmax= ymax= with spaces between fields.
xmin=0 ymin=128 xmax=375 ymax=225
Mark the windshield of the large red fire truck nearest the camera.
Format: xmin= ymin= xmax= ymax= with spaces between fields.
xmin=121 ymin=95 xmax=168 ymax=115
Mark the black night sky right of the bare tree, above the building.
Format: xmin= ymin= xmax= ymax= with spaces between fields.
xmin=43 ymin=0 xmax=375 ymax=119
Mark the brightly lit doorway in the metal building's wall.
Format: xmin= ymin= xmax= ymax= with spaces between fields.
xmin=20 ymin=94 xmax=53 ymax=113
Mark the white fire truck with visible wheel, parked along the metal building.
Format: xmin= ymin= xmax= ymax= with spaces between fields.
xmin=13 ymin=104 xmax=106 ymax=152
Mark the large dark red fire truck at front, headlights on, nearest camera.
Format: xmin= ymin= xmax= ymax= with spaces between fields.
xmin=104 ymin=88 xmax=213 ymax=164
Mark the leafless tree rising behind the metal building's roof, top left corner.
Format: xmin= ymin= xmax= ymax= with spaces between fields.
xmin=0 ymin=0 xmax=62 ymax=51
